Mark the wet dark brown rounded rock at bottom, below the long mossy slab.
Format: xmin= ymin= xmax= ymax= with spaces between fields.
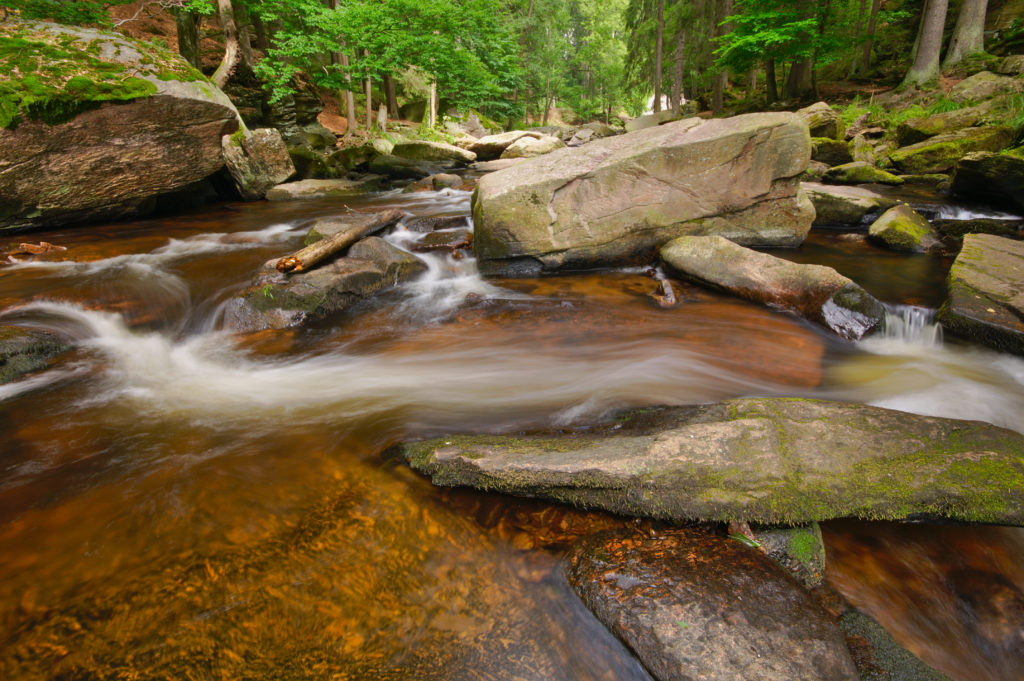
xmin=567 ymin=528 xmax=858 ymax=681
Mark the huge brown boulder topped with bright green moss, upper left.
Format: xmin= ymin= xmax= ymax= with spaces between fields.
xmin=0 ymin=22 xmax=241 ymax=229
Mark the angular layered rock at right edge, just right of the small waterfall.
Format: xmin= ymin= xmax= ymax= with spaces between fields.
xmin=939 ymin=235 xmax=1024 ymax=354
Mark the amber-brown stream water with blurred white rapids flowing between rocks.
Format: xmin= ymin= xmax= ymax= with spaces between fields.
xmin=0 ymin=190 xmax=1024 ymax=681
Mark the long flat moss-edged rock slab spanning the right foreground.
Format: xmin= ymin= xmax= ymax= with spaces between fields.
xmin=403 ymin=398 xmax=1024 ymax=525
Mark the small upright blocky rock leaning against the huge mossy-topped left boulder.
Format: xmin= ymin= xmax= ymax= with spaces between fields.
xmin=221 ymin=128 xmax=295 ymax=201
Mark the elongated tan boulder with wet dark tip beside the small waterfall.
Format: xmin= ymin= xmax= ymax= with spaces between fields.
xmin=662 ymin=237 xmax=885 ymax=340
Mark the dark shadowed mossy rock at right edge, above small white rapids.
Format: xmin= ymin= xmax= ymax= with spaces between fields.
xmin=950 ymin=146 xmax=1024 ymax=213
